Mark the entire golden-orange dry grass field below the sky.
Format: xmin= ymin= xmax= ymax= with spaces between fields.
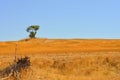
xmin=0 ymin=39 xmax=120 ymax=80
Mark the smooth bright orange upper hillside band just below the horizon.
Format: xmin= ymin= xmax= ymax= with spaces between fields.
xmin=0 ymin=39 xmax=120 ymax=54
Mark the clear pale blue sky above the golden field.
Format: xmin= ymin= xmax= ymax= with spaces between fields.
xmin=0 ymin=0 xmax=120 ymax=41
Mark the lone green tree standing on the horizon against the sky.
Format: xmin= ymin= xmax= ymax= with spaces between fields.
xmin=26 ymin=25 xmax=40 ymax=38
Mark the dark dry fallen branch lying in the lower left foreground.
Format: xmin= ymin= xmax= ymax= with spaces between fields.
xmin=0 ymin=56 xmax=30 ymax=80
